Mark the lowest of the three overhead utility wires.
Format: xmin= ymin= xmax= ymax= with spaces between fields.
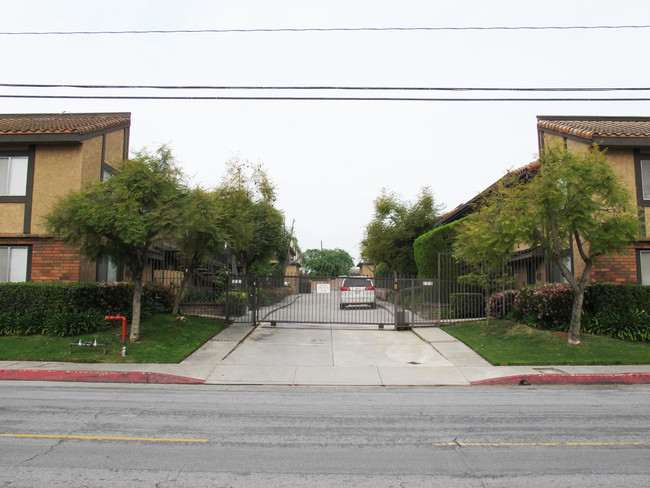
xmin=0 ymin=94 xmax=650 ymax=102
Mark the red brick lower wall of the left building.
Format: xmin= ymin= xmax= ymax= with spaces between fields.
xmin=0 ymin=236 xmax=81 ymax=282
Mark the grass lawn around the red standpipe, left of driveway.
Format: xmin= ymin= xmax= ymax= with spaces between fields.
xmin=0 ymin=315 xmax=228 ymax=363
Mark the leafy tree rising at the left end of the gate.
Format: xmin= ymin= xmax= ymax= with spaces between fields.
xmin=216 ymin=159 xmax=288 ymax=274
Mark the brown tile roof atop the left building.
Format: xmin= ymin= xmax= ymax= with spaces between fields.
xmin=0 ymin=113 xmax=131 ymax=135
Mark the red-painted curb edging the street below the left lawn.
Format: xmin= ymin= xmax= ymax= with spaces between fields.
xmin=0 ymin=369 xmax=205 ymax=384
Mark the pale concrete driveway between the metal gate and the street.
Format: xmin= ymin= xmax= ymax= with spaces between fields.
xmin=200 ymin=326 xmax=489 ymax=385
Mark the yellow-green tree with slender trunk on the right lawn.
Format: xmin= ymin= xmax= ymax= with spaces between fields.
xmin=456 ymin=146 xmax=640 ymax=344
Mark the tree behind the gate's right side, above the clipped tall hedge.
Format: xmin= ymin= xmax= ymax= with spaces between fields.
xmin=361 ymin=187 xmax=441 ymax=275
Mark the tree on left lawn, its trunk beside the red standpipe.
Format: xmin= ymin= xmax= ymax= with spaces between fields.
xmin=46 ymin=146 xmax=184 ymax=341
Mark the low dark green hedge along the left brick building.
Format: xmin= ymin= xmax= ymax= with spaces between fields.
xmin=0 ymin=282 xmax=175 ymax=336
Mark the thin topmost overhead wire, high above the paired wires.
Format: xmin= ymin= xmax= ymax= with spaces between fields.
xmin=0 ymin=25 xmax=650 ymax=36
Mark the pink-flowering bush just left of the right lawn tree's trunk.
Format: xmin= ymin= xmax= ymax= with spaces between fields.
xmin=514 ymin=283 xmax=573 ymax=330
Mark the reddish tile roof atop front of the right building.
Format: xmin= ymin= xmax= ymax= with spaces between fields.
xmin=537 ymin=117 xmax=650 ymax=139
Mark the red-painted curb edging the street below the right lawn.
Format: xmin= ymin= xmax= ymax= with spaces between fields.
xmin=470 ymin=373 xmax=650 ymax=386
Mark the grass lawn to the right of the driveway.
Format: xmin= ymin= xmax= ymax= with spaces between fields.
xmin=444 ymin=320 xmax=650 ymax=366
